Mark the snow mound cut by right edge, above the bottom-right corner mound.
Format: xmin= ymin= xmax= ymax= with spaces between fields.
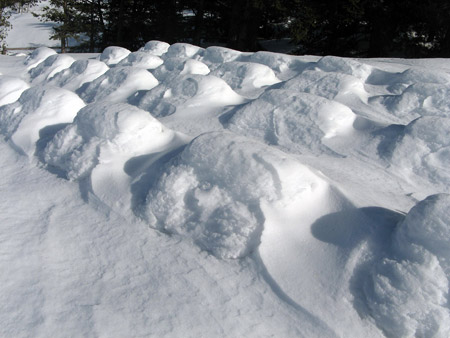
xmin=391 ymin=116 xmax=450 ymax=192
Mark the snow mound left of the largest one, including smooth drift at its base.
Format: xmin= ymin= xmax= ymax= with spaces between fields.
xmin=43 ymin=102 xmax=188 ymax=211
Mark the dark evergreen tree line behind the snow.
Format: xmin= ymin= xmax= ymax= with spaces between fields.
xmin=7 ymin=0 xmax=450 ymax=57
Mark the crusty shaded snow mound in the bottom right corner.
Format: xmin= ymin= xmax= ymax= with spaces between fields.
xmin=363 ymin=194 xmax=450 ymax=338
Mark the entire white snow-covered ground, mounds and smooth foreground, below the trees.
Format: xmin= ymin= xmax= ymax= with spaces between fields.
xmin=0 ymin=41 xmax=450 ymax=337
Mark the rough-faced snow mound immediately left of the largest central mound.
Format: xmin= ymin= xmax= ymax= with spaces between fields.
xmin=44 ymin=102 xmax=174 ymax=181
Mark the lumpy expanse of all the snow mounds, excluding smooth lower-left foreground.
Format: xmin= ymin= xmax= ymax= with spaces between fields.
xmin=0 ymin=41 xmax=450 ymax=337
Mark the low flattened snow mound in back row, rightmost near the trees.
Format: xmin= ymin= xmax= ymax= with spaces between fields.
xmin=314 ymin=56 xmax=373 ymax=81
